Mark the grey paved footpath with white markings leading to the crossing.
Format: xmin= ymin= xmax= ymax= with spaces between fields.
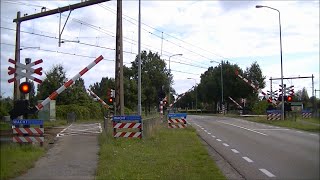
xmin=16 ymin=123 xmax=102 ymax=180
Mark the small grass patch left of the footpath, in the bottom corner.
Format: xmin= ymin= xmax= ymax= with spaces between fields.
xmin=0 ymin=144 xmax=45 ymax=180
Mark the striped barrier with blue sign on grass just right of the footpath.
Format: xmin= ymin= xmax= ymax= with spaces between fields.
xmin=112 ymin=115 xmax=142 ymax=139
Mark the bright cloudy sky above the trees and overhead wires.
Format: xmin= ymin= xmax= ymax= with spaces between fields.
xmin=1 ymin=0 xmax=320 ymax=98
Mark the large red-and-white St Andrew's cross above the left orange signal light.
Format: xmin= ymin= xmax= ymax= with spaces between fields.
xmin=8 ymin=59 xmax=43 ymax=84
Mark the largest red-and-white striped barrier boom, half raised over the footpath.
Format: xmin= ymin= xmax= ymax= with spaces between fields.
xmin=35 ymin=55 xmax=103 ymax=110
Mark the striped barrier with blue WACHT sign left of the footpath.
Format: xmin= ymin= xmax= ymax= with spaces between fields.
xmin=12 ymin=119 xmax=44 ymax=146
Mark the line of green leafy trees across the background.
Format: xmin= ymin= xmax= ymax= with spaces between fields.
xmin=0 ymin=51 xmax=319 ymax=118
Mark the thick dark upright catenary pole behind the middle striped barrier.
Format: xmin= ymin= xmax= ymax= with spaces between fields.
xmin=115 ymin=0 xmax=124 ymax=115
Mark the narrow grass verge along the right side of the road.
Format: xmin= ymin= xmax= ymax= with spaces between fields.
xmin=240 ymin=117 xmax=320 ymax=132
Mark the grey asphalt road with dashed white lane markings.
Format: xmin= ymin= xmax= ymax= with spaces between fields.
xmin=188 ymin=115 xmax=320 ymax=180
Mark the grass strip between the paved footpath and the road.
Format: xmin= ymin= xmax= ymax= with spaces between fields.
xmin=96 ymin=125 xmax=225 ymax=180
